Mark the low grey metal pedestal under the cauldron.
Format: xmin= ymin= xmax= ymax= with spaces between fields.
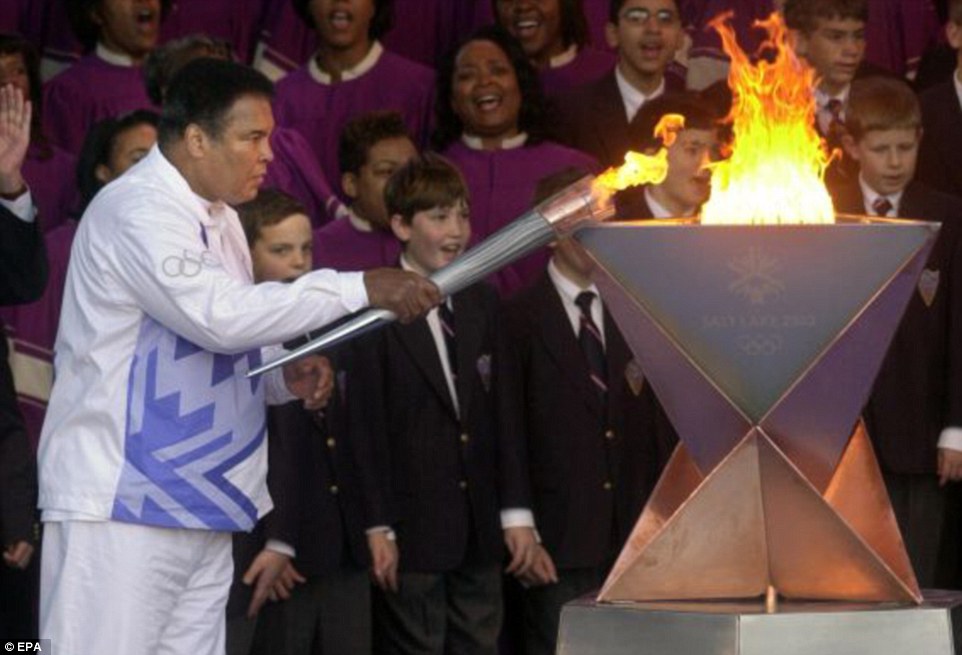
xmin=557 ymin=590 xmax=962 ymax=655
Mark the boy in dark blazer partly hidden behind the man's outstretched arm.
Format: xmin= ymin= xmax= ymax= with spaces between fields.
xmin=227 ymin=189 xmax=397 ymax=655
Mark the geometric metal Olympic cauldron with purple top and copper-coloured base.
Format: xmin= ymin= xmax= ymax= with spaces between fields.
xmin=577 ymin=216 xmax=938 ymax=603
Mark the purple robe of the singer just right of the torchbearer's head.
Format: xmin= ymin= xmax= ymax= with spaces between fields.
xmin=274 ymin=50 xmax=434 ymax=199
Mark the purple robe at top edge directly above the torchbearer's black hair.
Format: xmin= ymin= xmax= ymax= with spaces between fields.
xmin=160 ymin=0 xmax=266 ymax=62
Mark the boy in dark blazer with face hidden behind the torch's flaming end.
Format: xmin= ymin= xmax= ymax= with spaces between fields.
xmin=498 ymin=173 xmax=675 ymax=655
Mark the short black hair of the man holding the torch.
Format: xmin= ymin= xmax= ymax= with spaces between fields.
xmin=157 ymin=58 xmax=274 ymax=148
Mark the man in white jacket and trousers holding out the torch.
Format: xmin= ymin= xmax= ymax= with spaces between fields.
xmin=39 ymin=60 xmax=439 ymax=655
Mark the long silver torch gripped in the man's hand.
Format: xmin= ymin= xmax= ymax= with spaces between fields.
xmin=247 ymin=175 xmax=614 ymax=377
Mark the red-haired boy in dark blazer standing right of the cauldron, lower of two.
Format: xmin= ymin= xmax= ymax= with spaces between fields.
xmin=833 ymin=77 xmax=962 ymax=587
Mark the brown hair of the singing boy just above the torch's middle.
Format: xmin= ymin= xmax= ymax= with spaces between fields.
xmin=384 ymin=152 xmax=469 ymax=224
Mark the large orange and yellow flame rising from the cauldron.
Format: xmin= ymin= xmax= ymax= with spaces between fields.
xmin=701 ymin=12 xmax=835 ymax=224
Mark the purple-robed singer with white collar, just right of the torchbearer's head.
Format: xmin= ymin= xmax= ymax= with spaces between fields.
xmin=274 ymin=0 xmax=434 ymax=202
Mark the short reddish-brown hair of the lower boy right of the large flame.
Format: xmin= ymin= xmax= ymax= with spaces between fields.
xmin=845 ymin=76 xmax=922 ymax=143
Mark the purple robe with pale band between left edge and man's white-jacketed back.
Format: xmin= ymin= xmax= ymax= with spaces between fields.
xmin=0 ymin=221 xmax=77 ymax=448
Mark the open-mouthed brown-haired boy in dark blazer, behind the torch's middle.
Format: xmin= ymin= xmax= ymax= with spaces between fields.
xmin=352 ymin=154 xmax=535 ymax=655
